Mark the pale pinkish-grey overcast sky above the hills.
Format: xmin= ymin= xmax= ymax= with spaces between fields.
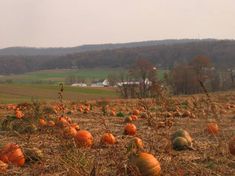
xmin=0 ymin=0 xmax=235 ymax=48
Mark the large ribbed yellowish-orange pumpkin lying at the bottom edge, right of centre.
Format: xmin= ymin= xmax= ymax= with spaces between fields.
xmin=129 ymin=152 xmax=161 ymax=176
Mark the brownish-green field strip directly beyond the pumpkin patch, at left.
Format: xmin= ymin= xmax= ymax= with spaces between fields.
xmin=0 ymin=83 xmax=118 ymax=104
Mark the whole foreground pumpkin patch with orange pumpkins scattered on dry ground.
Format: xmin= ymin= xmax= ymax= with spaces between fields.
xmin=0 ymin=90 xmax=235 ymax=176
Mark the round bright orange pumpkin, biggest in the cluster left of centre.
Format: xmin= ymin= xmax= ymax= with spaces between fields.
xmin=74 ymin=130 xmax=93 ymax=147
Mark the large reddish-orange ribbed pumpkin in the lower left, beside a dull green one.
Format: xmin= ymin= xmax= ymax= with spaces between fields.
xmin=0 ymin=144 xmax=25 ymax=166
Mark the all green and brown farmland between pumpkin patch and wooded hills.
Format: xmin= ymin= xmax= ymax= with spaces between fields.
xmin=0 ymin=68 xmax=165 ymax=103
